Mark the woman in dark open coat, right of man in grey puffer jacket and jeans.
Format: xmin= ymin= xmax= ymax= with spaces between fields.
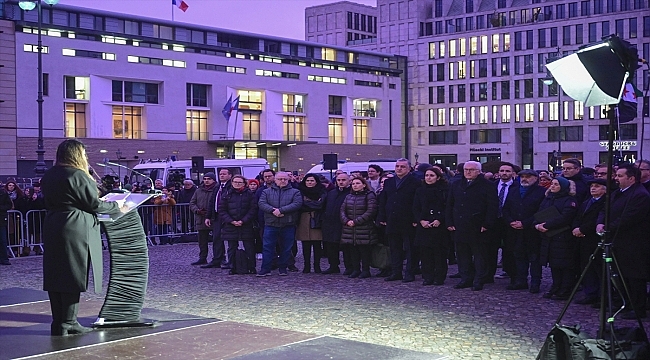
xmin=296 ymin=174 xmax=327 ymax=274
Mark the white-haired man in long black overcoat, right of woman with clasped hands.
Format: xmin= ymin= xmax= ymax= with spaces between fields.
xmin=445 ymin=161 xmax=499 ymax=291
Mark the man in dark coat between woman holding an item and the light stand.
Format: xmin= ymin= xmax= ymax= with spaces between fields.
xmin=572 ymin=178 xmax=607 ymax=305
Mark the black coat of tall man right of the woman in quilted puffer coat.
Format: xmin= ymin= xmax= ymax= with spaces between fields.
xmin=377 ymin=174 xmax=422 ymax=233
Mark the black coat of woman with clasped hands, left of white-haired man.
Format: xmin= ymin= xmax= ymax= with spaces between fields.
xmin=413 ymin=182 xmax=449 ymax=247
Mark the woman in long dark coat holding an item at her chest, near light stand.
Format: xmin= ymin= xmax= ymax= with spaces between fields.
xmin=533 ymin=177 xmax=578 ymax=300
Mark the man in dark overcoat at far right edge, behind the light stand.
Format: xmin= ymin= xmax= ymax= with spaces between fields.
xmin=596 ymin=164 xmax=650 ymax=319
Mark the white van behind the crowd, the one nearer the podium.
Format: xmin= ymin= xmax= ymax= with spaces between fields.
xmin=130 ymin=159 xmax=269 ymax=185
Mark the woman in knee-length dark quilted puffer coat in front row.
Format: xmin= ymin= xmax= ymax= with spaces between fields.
xmin=341 ymin=177 xmax=378 ymax=279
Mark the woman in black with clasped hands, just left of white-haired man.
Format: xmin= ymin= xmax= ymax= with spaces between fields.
xmin=413 ymin=167 xmax=449 ymax=285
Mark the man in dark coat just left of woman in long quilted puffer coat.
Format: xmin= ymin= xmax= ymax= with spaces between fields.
xmin=314 ymin=173 xmax=352 ymax=275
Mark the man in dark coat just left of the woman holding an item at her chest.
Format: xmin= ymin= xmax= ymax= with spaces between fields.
xmin=503 ymin=169 xmax=546 ymax=294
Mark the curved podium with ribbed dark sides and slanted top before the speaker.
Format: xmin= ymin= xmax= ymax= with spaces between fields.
xmin=92 ymin=193 xmax=155 ymax=329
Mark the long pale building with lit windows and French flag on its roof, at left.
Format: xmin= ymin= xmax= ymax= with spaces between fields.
xmin=0 ymin=3 xmax=404 ymax=177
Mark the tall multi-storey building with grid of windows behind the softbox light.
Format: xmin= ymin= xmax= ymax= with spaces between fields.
xmin=306 ymin=0 xmax=650 ymax=169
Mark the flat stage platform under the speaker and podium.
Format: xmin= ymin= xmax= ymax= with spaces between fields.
xmin=0 ymin=288 xmax=447 ymax=360
